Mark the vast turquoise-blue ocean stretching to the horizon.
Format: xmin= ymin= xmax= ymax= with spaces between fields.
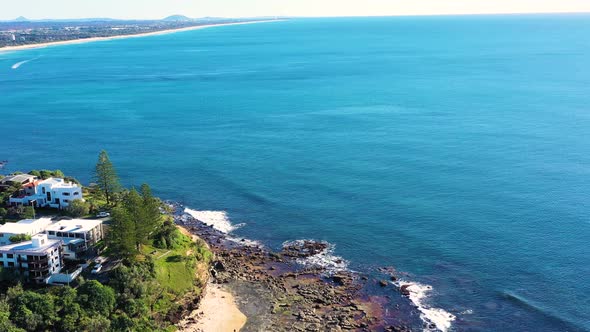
xmin=0 ymin=15 xmax=590 ymax=331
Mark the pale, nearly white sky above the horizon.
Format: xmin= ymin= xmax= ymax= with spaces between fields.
xmin=0 ymin=0 xmax=590 ymax=19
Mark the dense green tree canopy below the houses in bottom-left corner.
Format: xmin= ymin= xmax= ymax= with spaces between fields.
xmin=0 ymin=261 xmax=175 ymax=332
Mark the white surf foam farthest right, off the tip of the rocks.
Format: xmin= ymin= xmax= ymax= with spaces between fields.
xmin=395 ymin=280 xmax=457 ymax=332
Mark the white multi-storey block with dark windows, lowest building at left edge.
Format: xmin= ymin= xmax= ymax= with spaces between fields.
xmin=0 ymin=234 xmax=63 ymax=284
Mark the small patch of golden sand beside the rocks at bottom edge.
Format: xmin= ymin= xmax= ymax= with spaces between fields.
xmin=178 ymin=283 xmax=246 ymax=332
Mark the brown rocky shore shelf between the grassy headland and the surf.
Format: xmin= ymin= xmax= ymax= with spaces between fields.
xmin=175 ymin=207 xmax=415 ymax=332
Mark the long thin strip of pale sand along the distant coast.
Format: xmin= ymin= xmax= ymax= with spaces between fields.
xmin=0 ymin=20 xmax=283 ymax=53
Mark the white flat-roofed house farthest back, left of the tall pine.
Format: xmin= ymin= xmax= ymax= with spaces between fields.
xmin=9 ymin=178 xmax=84 ymax=209
